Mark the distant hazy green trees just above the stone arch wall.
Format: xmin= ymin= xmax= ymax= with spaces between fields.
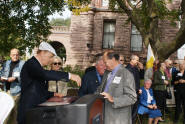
xmin=50 ymin=18 xmax=71 ymax=27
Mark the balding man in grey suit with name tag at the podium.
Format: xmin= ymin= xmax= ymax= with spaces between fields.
xmin=96 ymin=52 xmax=137 ymax=124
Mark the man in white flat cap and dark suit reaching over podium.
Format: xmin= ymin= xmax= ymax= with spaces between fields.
xmin=17 ymin=42 xmax=81 ymax=124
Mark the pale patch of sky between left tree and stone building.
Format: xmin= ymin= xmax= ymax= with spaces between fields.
xmin=49 ymin=7 xmax=71 ymax=20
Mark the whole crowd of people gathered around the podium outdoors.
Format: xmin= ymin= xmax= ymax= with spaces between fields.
xmin=0 ymin=42 xmax=185 ymax=124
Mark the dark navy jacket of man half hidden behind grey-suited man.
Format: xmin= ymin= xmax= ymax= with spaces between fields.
xmin=78 ymin=69 xmax=101 ymax=96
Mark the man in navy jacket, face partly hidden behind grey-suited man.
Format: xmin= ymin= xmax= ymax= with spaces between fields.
xmin=78 ymin=54 xmax=106 ymax=96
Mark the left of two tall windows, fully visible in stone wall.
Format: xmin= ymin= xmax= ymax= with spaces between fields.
xmin=103 ymin=20 xmax=116 ymax=49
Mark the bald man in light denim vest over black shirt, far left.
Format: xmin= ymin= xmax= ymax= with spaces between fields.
xmin=0 ymin=48 xmax=24 ymax=96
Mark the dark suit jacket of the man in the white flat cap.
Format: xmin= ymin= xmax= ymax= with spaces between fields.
xmin=18 ymin=57 xmax=68 ymax=124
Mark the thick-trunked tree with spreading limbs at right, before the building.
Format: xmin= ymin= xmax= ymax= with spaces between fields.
xmin=74 ymin=0 xmax=185 ymax=60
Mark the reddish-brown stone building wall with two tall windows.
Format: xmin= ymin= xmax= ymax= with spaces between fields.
xmin=47 ymin=0 xmax=181 ymax=68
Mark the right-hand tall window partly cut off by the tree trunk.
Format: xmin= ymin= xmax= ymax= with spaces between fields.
xmin=131 ymin=24 xmax=143 ymax=51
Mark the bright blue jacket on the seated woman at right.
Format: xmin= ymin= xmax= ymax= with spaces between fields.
xmin=138 ymin=87 xmax=156 ymax=114
